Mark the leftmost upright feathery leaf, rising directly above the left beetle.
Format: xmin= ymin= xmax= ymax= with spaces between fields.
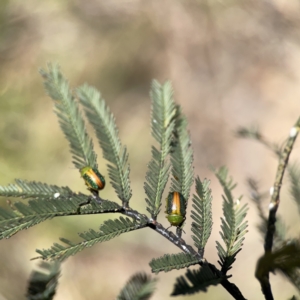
xmin=40 ymin=64 xmax=97 ymax=169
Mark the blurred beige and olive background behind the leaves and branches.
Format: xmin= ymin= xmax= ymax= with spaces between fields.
xmin=0 ymin=0 xmax=300 ymax=300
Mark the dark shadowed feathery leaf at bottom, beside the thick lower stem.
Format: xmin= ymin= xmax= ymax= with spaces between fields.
xmin=171 ymin=264 xmax=226 ymax=296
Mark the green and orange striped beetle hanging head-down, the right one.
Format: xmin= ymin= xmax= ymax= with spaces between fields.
xmin=165 ymin=192 xmax=185 ymax=226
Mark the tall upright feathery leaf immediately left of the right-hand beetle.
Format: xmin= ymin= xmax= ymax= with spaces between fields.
xmin=144 ymin=80 xmax=176 ymax=219
